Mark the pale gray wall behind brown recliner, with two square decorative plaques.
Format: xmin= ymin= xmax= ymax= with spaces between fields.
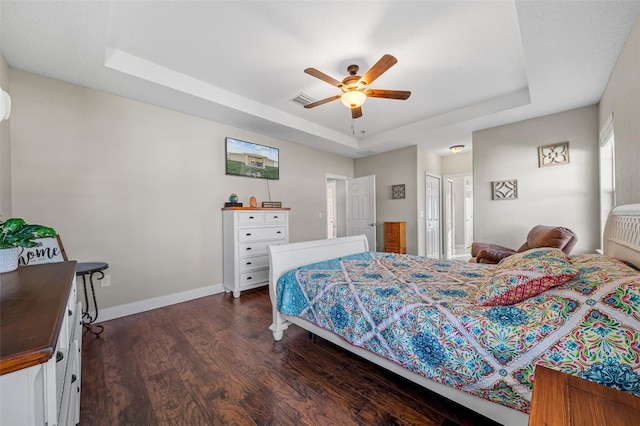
xmin=473 ymin=105 xmax=600 ymax=253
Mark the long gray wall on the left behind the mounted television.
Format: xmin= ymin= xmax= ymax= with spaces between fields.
xmin=3 ymin=69 xmax=353 ymax=308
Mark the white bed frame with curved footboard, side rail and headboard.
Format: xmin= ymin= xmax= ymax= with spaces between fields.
xmin=268 ymin=204 xmax=640 ymax=426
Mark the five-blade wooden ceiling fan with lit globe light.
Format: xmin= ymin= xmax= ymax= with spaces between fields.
xmin=304 ymin=54 xmax=411 ymax=118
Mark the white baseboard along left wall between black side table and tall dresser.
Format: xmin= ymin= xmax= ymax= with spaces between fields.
xmin=89 ymin=284 xmax=224 ymax=324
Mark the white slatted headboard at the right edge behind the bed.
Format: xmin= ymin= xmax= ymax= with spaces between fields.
xmin=603 ymin=204 xmax=640 ymax=268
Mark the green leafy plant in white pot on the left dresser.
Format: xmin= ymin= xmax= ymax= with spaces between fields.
xmin=0 ymin=218 xmax=56 ymax=272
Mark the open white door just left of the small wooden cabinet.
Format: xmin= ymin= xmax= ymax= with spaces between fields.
xmin=347 ymin=176 xmax=377 ymax=251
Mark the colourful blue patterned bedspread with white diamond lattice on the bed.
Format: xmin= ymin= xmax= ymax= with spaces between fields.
xmin=277 ymin=252 xmax=640 ymax=413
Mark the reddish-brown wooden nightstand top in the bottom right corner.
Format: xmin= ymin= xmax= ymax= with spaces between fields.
xmin=529 ymin=366 xmax=640 ymax=426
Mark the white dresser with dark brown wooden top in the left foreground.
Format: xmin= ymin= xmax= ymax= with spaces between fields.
xmin=0 ymin=261 xmax=82 ymax=426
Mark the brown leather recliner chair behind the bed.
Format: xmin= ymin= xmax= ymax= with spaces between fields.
xmin=469 ymin=225 xmax=578 ymax=263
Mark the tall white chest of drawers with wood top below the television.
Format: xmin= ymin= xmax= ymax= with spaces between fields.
xmin=222 ymin=207 xmax=290 ymax=297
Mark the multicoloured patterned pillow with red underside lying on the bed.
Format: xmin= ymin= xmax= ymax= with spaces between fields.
xmin=476 ymin=248 xmax=579 ymax=306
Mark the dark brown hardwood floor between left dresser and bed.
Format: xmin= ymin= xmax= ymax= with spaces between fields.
xmin=80 ymin=288 xmax=502 ymax=426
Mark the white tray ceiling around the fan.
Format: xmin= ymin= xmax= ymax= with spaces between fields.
xmin=0 ymin=0 xmax=640 ymax=158
